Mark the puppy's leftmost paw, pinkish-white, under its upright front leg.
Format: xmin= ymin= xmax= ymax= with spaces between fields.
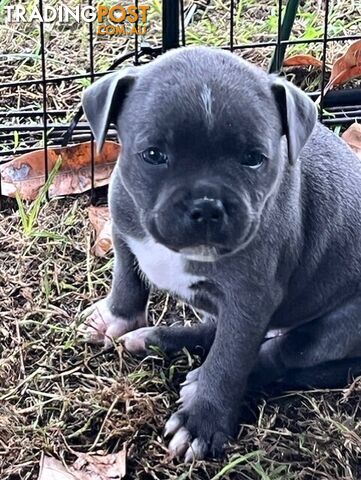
xmin=78 ymin=298 xmax=146 ymax=347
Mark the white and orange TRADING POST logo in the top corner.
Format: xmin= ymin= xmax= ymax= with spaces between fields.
xmin=5 ymin=3 xmax=150 ymax=35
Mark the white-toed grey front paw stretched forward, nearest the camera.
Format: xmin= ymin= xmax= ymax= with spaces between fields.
xmin=164 ymin=367 xmax=236 ymax=463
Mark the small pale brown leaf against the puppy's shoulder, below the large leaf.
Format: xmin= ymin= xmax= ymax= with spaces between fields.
xmin=88 ymin=206 xmax=112 ymax=257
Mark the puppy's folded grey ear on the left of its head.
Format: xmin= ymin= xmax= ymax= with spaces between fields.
xmin=82 ymin=67 xmax=138 ymax=152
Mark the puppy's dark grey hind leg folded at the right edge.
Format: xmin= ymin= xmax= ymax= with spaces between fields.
xmin=249 ymin=298 xmax=361 ymax=388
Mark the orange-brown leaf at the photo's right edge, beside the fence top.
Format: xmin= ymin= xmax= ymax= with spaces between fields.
xmin=325 ymin=40 xmax=361 ymax=91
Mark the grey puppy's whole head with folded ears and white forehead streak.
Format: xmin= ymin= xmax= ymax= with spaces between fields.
xmin=83 ymin=47 xmax=316 ymax=260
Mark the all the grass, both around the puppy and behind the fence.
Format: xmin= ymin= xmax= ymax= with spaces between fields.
xmin=0 ymin=0 xmax=361 ymax=480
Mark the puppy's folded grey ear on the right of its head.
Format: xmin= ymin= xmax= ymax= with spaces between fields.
xmin=271 ymin=78 xmax=317 ymax=165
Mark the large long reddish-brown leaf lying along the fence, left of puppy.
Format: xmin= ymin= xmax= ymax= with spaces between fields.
xmin=0 ymin=141 xmax=121 ymax=200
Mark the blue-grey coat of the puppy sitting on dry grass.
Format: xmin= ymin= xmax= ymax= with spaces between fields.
xmin=83 ymin=48 xmax=361 ymax=460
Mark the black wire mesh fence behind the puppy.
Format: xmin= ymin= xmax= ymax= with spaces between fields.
xmin=0 ymin=0 xmax=361 ymax=202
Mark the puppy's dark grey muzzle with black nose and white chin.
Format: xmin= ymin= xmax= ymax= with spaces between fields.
xmin=146 ymin=183 xmax=252 ymax=255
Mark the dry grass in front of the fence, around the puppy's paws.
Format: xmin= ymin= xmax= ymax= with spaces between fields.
xmin=0 ymin=195 xmax=361 ymax=480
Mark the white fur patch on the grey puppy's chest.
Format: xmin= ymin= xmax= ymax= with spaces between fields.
xmin=127 ymin=237 xmax=201 ymax=300
